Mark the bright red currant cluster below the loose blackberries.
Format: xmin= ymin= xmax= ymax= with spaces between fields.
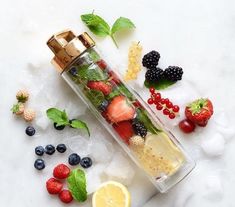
xmin=148 ymin=87 xmax=180 ymax=119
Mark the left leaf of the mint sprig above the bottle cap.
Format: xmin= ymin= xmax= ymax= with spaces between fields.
xmin=81 ymin=14 xmax=110 ymax=37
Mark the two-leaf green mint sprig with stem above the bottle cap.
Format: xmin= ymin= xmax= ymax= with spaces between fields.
xmin=81 ymin=13 xmax=135 ymax=47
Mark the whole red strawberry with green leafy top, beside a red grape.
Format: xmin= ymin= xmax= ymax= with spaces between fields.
xmin=185 ymin=98 xmax=213 ymax=127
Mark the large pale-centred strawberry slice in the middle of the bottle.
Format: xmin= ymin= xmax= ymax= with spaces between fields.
xmin=107 ymin=95 xmax=135 ymax=123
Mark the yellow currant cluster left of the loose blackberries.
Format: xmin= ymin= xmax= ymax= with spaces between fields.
xmin=124 ymin=42 xmax=142 ymax=81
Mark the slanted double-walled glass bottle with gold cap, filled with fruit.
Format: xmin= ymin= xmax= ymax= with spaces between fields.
xmin=47 ymin=30 xmax=195 ymax=192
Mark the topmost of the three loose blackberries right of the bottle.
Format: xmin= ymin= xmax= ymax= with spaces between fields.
xmin=142 ymin=50 xmax=160 ymax=69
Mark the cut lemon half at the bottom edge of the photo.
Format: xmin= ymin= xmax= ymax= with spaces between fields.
xmin=92 ymin=181 xmax=131 ymax=207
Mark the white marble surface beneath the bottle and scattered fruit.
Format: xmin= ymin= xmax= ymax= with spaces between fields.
xmin=0 ymin=0 xmax=235 ymax=207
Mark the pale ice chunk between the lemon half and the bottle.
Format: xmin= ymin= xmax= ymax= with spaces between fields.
xmin=104 ymin=152 xmax=135 ymax=185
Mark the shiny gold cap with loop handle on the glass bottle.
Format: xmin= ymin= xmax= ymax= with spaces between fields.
xmin=47 ymin=30 xmax=95 ymax=73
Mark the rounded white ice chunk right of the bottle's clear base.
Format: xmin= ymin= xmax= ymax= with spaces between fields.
xmin=201 ymin=133 xmax=225 ymax=157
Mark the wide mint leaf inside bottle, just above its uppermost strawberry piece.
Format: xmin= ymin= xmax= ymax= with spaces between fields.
xmin=78 ymin=66 xmax=108 ymax=81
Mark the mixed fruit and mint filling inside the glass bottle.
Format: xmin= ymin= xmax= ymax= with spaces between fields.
xmin=62 ymin=48 xmax=185 ymax=179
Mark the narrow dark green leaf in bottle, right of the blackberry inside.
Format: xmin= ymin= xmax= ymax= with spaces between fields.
xmin=136 ymin=109 xmax=162 ymax=134
